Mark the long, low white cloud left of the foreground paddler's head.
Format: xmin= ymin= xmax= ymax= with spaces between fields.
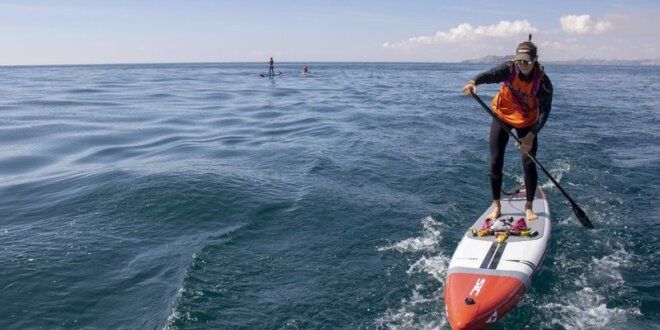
xmin=383 ymin=20 xmax=538 ymax=48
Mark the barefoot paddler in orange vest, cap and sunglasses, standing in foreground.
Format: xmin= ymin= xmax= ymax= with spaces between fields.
xmin=463 ymin=34 xmax=552 ymax=220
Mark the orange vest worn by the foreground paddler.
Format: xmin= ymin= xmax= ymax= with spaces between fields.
xmin=491 ymin=63 xmax=543 ymax=128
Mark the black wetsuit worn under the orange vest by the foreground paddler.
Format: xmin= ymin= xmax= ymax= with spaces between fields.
xmin=473 ymin=62 xmax=552 ymax=201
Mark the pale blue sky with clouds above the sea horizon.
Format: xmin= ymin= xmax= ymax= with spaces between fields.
xmin=0 ymin=0 xmax=660 ymax=65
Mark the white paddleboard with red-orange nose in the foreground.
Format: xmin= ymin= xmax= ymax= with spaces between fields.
xmin=445 ymin=189 xmax=552 ymax=329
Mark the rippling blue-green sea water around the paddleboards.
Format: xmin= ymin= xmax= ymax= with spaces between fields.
xmin=0 ymin=63 xmax=660 ymax=329
